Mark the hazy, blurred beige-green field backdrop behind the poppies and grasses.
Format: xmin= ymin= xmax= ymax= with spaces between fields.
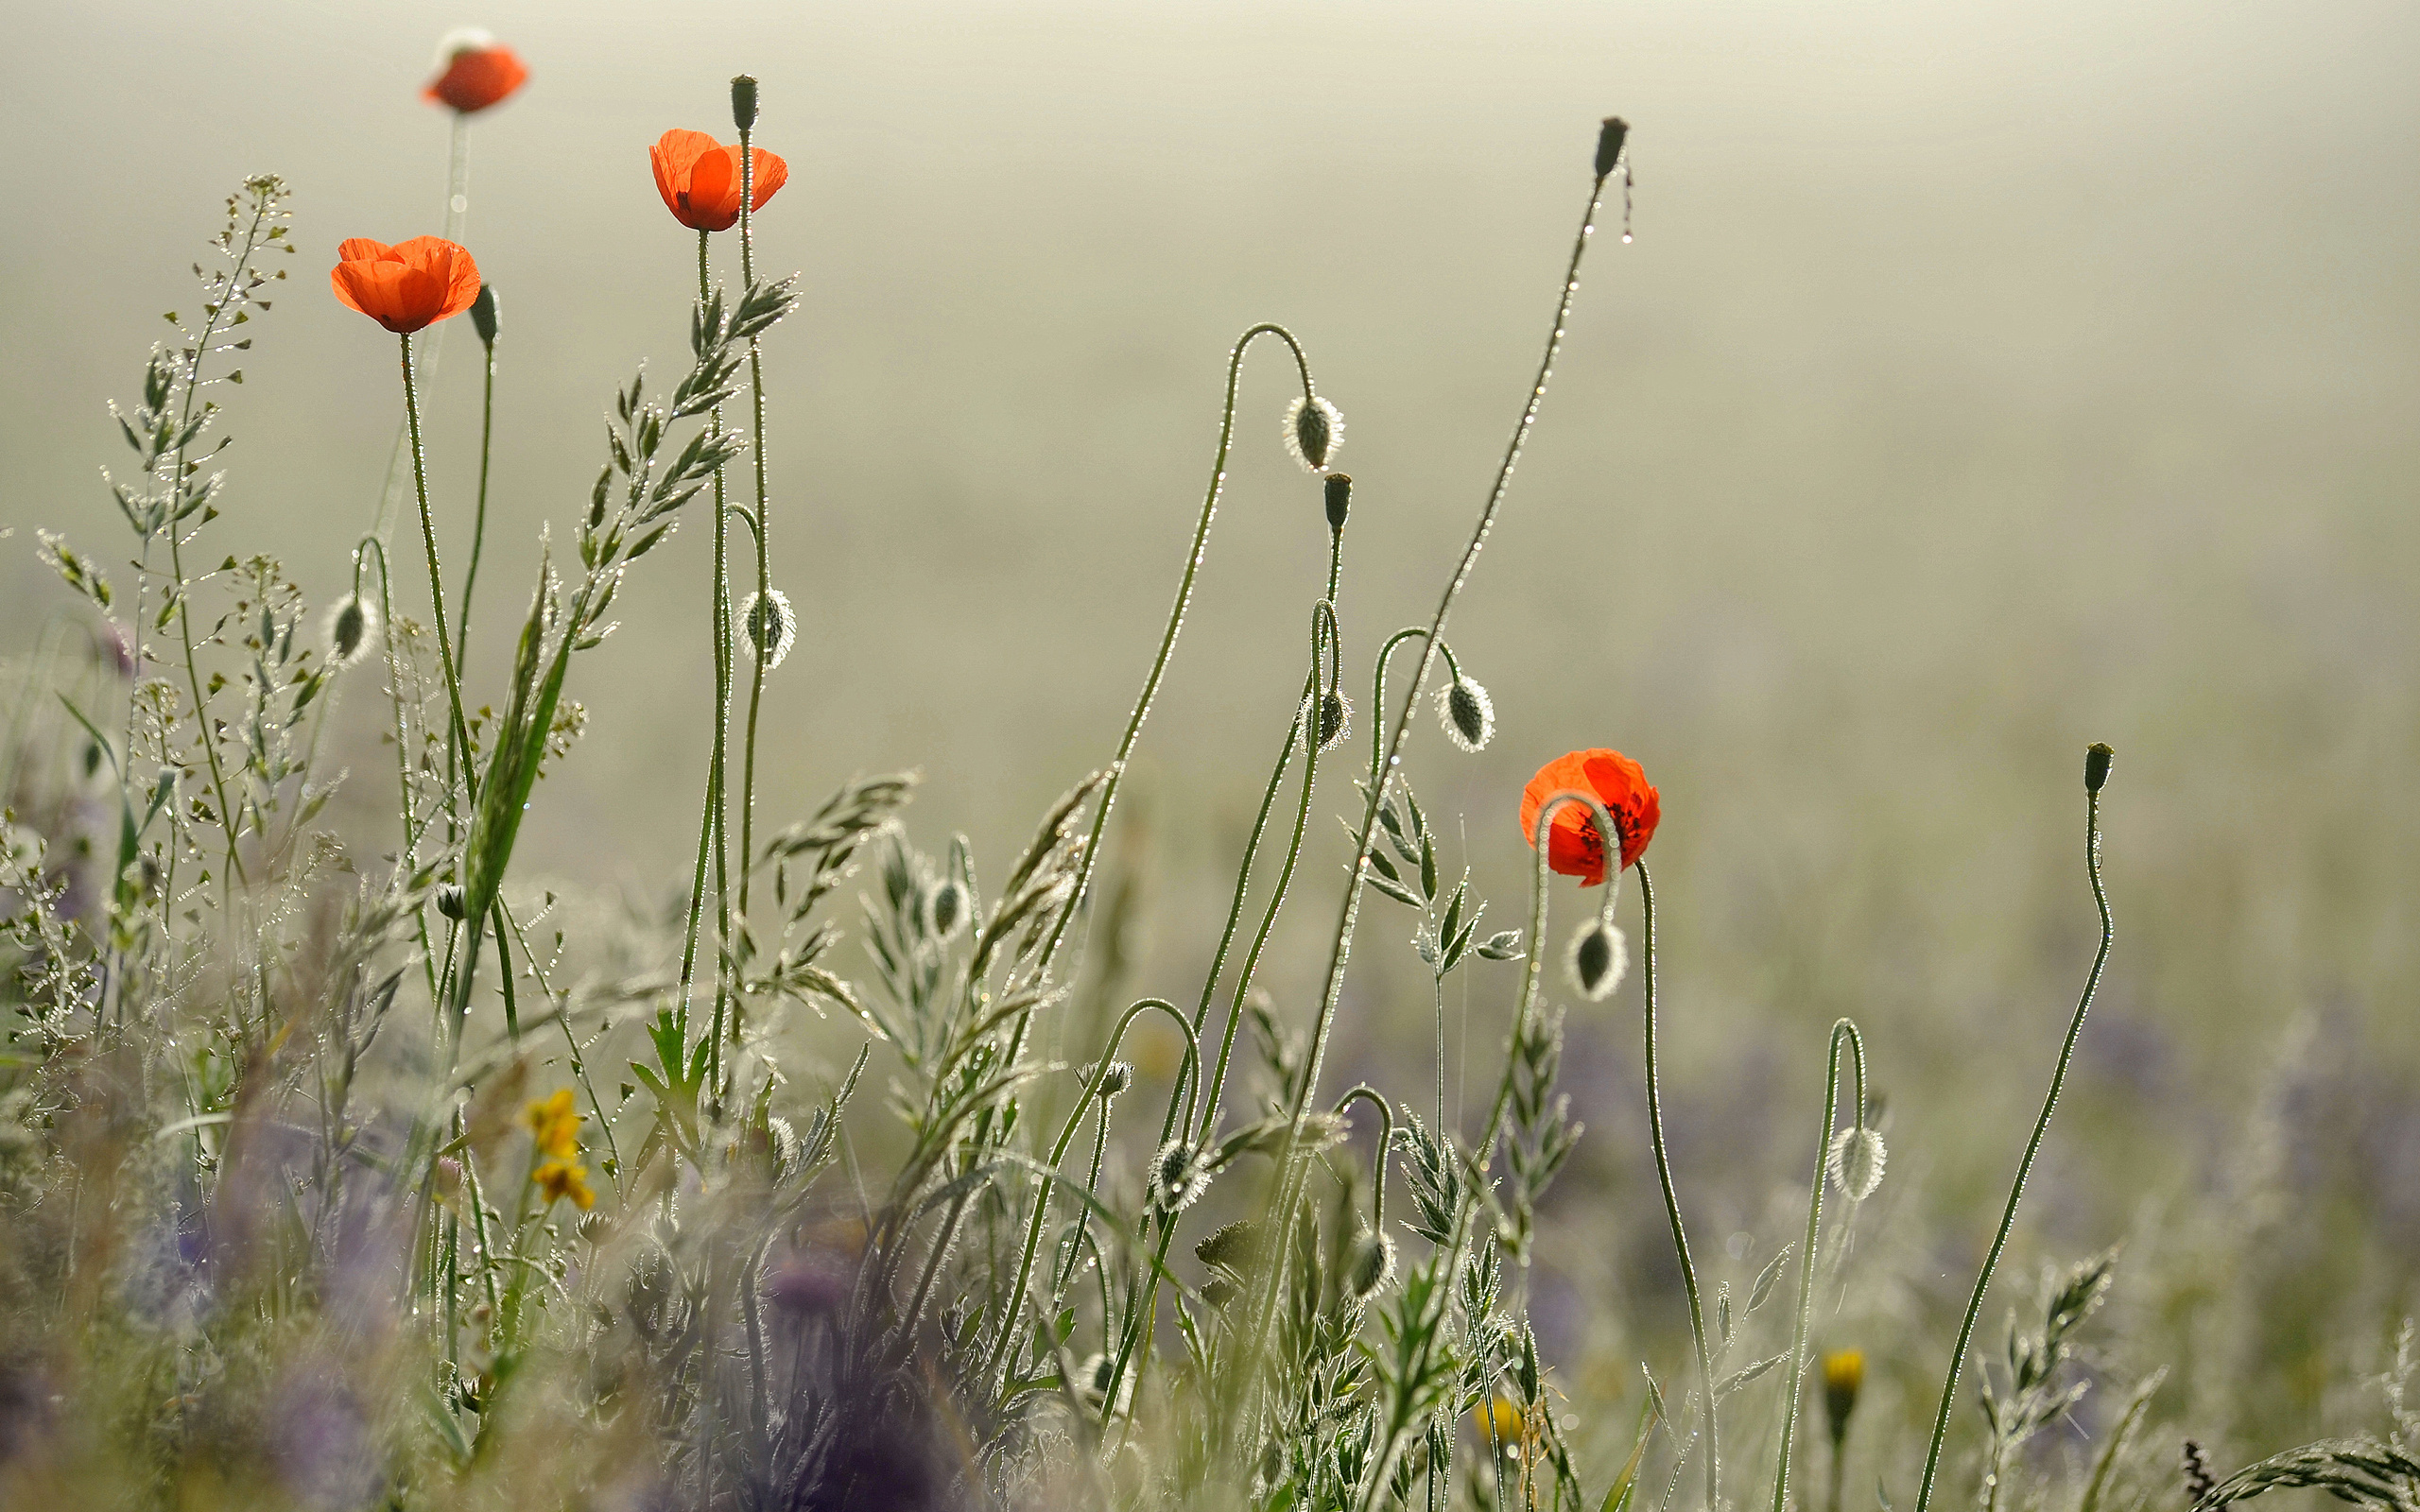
xmin=0 ymin=0 xmax=2420 ymax=1461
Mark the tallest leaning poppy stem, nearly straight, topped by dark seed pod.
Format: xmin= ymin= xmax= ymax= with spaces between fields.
xmin=1246 ymin=150 xmax=1615 ymax=1402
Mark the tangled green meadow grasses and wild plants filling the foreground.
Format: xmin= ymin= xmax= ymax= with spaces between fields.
xmin=0 ymin=64 xmax=2420 ymax=1512
